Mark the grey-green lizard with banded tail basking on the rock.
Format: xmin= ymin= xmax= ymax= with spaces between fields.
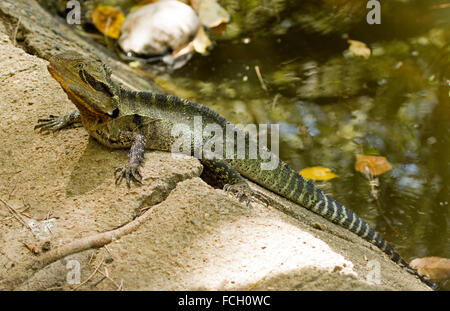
xmin=35 ymin=51 xmax=435 ymax=288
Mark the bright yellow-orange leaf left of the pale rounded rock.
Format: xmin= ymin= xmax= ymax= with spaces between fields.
xmin=91 ymin=4 xmax=125 ymax=39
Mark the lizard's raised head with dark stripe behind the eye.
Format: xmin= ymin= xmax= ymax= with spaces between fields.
xmin=47 ymin=51 xmax=119 ymax=118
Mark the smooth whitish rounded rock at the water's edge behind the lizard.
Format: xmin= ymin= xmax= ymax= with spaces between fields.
xmin=119 ymin=0 xmax=200 ymax=55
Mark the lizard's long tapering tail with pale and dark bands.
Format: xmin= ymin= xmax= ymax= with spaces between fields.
xmin=243 ymin=160 xmax=436 ymax=289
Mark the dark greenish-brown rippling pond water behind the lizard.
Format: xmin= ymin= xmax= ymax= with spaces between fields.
xmin=153 ymin=1 xmax=450 ymax=288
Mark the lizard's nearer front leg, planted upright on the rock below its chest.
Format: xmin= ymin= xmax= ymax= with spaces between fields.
xmin=114 ymin=133 xmax=147 ymax=187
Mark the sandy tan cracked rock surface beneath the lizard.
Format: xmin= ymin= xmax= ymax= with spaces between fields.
xmin=0 ymin=1 xmax=427 ymax=290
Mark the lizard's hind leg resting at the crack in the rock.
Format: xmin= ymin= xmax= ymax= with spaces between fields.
xmin=201 ymin=159 xmax=268 ymax=206
